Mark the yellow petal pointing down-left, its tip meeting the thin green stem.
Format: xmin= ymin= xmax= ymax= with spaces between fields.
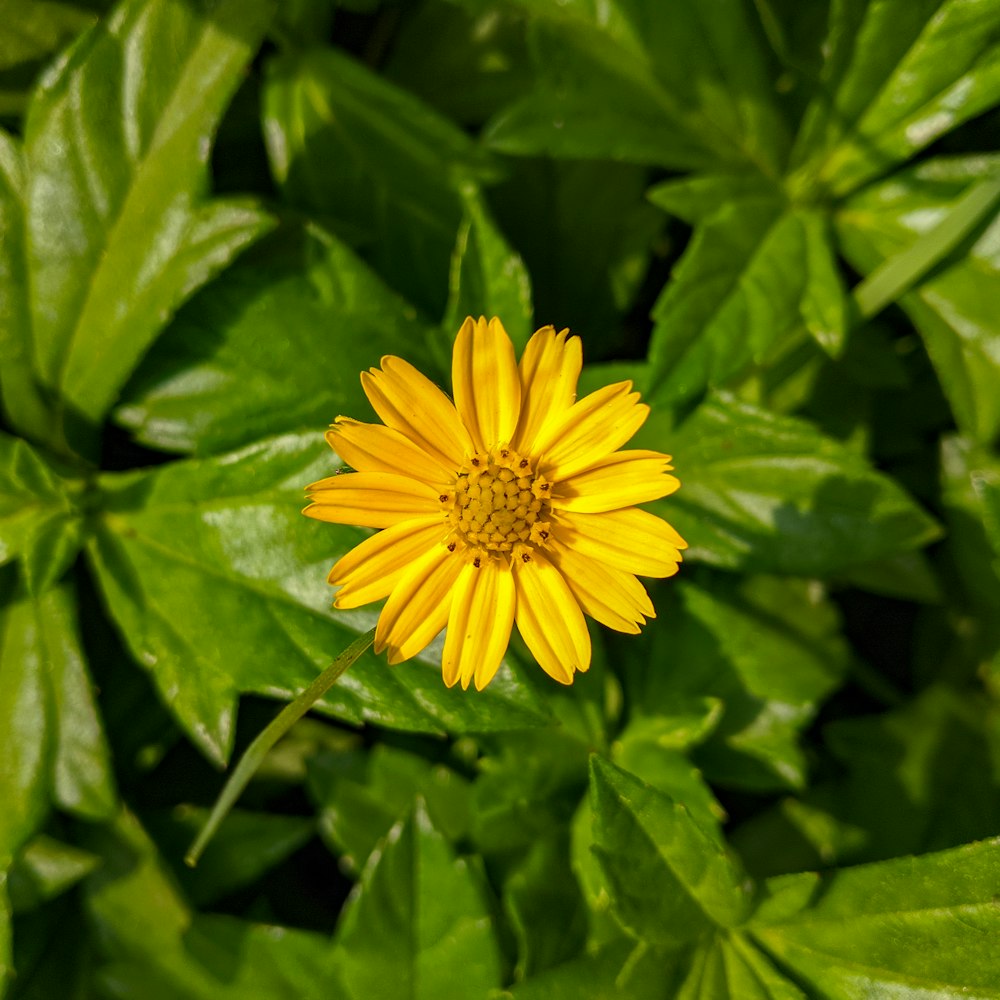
xmin=375 ymin=545 xmax=462 ymax=663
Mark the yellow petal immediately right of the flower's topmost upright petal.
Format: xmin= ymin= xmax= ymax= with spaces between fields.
xmin=511 ymin=326 xmax=583 ymax=454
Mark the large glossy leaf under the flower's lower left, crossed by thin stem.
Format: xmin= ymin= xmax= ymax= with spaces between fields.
xmin=88 ymin=434 xmax=544 ymax=762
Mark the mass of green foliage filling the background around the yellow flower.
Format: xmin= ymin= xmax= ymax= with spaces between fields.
xmin=0 ymin=0 xmax=1000 ymax=1000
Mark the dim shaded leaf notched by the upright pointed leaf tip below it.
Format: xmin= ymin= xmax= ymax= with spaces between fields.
xmin=306 ymin=744 xmax=470 ymax=874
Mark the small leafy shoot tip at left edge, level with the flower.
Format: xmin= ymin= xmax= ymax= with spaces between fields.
xmin=0 ymin=432 xmax=83 ymax=594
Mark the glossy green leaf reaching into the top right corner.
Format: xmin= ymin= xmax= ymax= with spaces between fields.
xmin=790 ymin=0 xmax=1000 ymax=195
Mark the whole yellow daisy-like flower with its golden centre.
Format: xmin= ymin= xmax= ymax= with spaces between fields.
xmin=304 ymin=317 xmax=687 ymax=690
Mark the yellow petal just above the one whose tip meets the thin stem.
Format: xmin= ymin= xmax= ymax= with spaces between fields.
xmin=327 ymin=516 xmax=448 ymax=608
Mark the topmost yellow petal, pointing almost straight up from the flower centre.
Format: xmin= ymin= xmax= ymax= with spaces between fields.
xmin=451 ymin=316 xmax=521 ymax=451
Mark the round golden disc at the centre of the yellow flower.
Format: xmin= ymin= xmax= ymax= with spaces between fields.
xmin=442 ymin=445 xmax=552 ymax=553
